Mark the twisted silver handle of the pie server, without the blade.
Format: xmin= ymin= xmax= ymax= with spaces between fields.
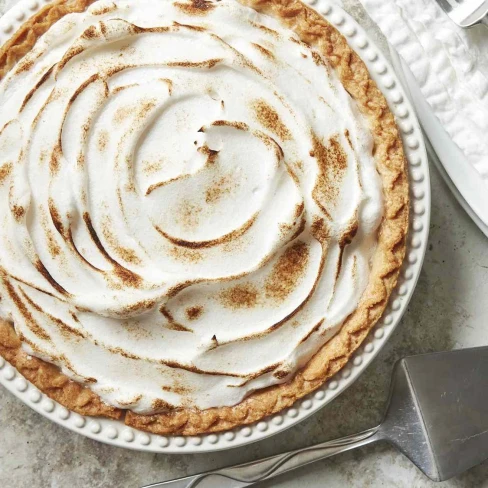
xmin=139 ymin=427 xmax=379 ymax=488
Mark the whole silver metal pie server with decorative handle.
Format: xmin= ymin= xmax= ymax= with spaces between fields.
xmin=146 ymin=347 xmax=488 ymax=488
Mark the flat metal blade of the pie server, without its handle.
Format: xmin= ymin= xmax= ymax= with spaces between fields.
xmin=386 ymin=347 xmax=488 ymax=480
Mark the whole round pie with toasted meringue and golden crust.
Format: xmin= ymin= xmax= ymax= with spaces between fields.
xmin=0 ymin=0 xmax=409 ymax=435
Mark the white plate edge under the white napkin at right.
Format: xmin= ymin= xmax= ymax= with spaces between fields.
xmin=390 ymin=47 xmax=488 ymax=237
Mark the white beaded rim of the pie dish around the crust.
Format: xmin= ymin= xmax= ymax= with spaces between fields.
xmin=0 ymin=0 xmax=430 ymax=453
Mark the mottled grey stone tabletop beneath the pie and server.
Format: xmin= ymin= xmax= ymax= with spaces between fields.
xmin=0 ymin=0 xmax=488 ymax=488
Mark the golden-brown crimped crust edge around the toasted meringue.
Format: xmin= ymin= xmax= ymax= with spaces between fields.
xmin=0 ymin=0 xmax=409 ymax=435
